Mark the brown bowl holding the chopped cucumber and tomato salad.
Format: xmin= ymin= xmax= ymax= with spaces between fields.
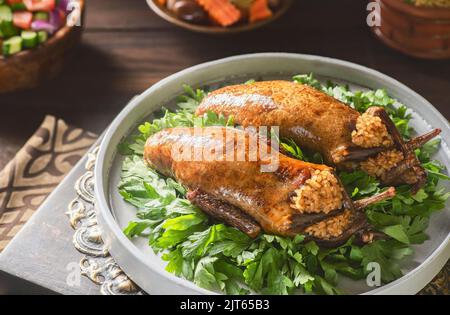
xmin=0 ymin=0 xmax=85 ymax=93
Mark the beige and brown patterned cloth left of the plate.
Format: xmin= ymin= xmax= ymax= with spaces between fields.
xmin=0 ymin=116 xmax=97 ymax=252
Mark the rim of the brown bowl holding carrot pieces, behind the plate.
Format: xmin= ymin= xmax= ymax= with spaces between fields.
xmin=147 ymin=0 xmax=293 ymax=34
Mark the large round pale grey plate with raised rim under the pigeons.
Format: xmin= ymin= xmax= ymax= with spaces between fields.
xmin=95 ymin=53 xmax=450 ymax=294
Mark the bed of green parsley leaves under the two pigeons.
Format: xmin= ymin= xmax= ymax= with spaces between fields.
xmin=119 ymin=75 xmax=450 ymax=294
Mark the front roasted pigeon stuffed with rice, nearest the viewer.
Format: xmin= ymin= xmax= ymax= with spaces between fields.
xmin=144 ymin=127 xmax=395 ymax=246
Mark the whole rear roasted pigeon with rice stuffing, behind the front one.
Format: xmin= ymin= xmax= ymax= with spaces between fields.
xmin=196 ymin=81 xmax=436 ymax=190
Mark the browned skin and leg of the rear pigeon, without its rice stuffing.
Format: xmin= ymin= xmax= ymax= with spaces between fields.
xmin=196 ymin=81 xmax=439 ymax=190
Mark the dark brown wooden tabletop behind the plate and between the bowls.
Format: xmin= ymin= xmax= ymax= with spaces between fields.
xmin=0 ymin=0 xmax=450 ymax=169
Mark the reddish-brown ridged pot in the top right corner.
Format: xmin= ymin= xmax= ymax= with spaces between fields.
xmin=371 ymin=0 xmax=450 ymax=59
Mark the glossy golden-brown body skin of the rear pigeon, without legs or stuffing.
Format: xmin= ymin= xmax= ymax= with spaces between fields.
xmin=196 ymin=81 xmax=359 ymax=164
